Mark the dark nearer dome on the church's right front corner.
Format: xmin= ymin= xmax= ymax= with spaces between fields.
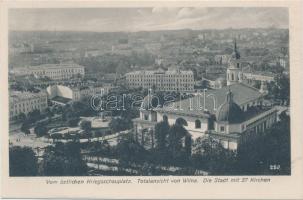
xmin=216 ymin=91 xmax=244 ymax=123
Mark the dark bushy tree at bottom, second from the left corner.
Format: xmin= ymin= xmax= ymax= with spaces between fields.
xmin=42 ymin=142 xmax=87 ymax=176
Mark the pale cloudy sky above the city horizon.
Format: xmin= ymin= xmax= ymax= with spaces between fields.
xmin=9 ymin=7 xmax=288 ymax=32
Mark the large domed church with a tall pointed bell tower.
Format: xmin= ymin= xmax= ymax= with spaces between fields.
xmin=133 ymin=43 xmax=277 ymax=151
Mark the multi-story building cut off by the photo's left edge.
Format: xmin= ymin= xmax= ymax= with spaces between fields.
xmin=9 ymin=91 xmax=47 ymax=118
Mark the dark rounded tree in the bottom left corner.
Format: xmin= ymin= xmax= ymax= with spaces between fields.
xmin=9 ymin=146 xmax=38 ymax=176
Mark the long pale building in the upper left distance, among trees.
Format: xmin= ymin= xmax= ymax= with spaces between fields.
xmin=16 ymin=63 xmax=85 ymax=80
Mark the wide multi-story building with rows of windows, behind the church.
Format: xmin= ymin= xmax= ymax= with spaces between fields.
xmin=125 ymin=69 xmax=194 ymax=92
